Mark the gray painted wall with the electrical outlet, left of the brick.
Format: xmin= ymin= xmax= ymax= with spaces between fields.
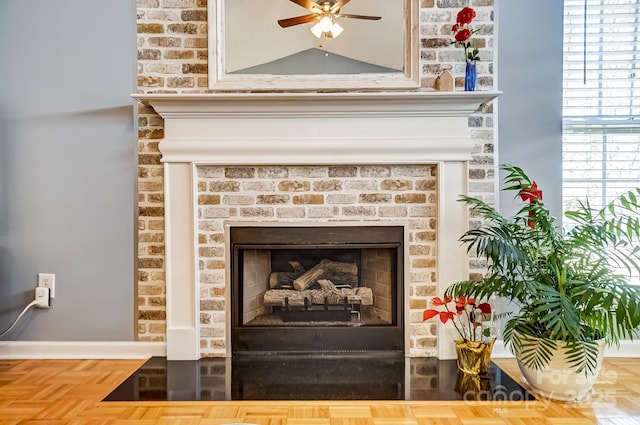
xmin=0 ymin=0 xmax=137 ymax=341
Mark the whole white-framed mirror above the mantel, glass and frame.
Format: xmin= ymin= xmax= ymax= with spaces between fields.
xmin=208 ymin=0 xmax=419 ymax=92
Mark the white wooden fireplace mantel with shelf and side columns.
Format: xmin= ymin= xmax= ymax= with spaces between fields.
xmin=133 ymin=91 xmax=500 ymax=360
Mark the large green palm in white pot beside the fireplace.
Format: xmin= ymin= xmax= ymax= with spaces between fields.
xmin=445 ymin=165 xmax=640 ymax=400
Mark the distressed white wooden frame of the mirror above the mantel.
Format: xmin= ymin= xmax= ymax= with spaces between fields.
xmin=207 ymin=0 xmax=420 ymax=92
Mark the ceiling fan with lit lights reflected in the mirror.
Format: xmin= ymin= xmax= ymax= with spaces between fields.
xmin=278 ymin=0 xmax=382 ymax=38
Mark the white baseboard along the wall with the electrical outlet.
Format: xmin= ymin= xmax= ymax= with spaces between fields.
xmin=0 ymin=341 xmax=167 ymax=359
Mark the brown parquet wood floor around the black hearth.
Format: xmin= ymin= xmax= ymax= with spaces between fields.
xmin=0 ymin=358 xmax=640 ymax=425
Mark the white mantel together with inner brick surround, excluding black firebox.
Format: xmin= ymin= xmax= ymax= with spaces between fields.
xmin=135 ymin=91 xmax=497 ymax=360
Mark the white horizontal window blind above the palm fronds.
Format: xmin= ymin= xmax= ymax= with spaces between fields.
xmin=563 ymin=0 xmax=640 ymax=209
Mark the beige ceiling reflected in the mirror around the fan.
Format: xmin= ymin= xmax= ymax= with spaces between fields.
xmin=224 ymin=0 xmax=404 ymax=73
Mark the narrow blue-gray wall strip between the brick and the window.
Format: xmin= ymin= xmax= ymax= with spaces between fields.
xmin=496 ymin=0 xmax=564 ymax=219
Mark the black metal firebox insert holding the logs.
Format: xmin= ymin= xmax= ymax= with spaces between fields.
xmin=229 ymin=225 xmax=404 ymax=353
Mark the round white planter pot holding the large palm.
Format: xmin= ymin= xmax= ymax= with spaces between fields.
xmin=515 ymin=341 xmax=605 ymax=401
